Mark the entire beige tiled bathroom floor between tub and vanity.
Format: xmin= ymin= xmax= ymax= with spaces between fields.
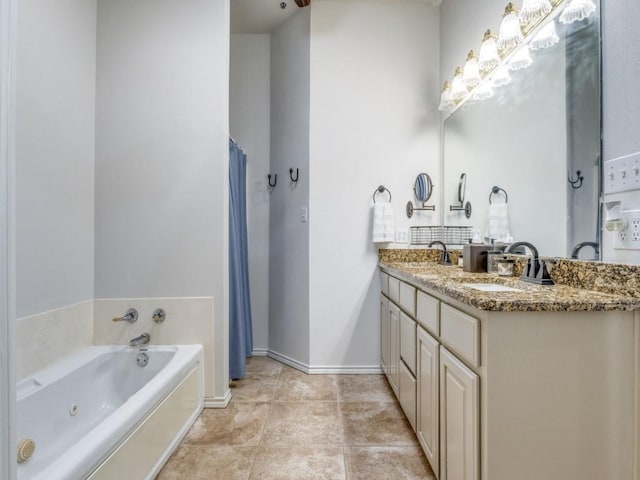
xmin=157 ymin=357 xmax=435 ymax=480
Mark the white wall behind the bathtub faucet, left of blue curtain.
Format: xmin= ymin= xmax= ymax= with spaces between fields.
xmin=95 ymin=0 xmax=229 ymax=397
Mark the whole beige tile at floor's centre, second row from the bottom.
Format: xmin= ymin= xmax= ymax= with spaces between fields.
xmin=260 ymin=402 xmax=342 ymax=446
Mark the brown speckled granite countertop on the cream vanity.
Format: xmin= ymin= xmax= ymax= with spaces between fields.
xmin=379 ymin=259 xmax=640 ymax=312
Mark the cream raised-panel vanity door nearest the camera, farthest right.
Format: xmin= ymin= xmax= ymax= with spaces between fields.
xmin=439 ymin=347 xmax=480 ymax=480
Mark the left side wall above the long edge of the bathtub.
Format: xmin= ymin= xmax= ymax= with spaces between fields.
xmin=16 ymin=0 xmax=96 ymax=320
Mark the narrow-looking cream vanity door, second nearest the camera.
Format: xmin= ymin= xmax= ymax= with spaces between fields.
xmin=416 ymin=327 xmax=440 ymax=477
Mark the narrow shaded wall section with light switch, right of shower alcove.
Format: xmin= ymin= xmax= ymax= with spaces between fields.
xmin=269 ymin=8 xmax=314 ymax=364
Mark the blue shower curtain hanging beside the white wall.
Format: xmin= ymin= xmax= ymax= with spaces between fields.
xmin=229 ymin=140 xmax=253 ymax=379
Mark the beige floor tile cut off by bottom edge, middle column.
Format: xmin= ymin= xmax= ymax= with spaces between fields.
xmin=250 ymin=447 xmax=346 ymax=480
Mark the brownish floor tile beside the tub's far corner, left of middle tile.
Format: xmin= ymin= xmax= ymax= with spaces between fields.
xmin=182 ymin=401 xmax=269 ymax=445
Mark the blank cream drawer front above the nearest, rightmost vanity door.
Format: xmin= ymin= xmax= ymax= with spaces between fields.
xmin=440 ymin=304 xmax=480 ymax=367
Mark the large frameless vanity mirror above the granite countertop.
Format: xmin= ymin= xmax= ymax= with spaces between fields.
xmin=443 ymin=1 xmax=601 ymax=259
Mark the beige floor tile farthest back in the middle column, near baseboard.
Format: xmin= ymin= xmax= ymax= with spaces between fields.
xmin=273 ymin=369 xmax=338 ymax=401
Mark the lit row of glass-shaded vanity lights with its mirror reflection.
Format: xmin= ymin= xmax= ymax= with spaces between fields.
xmin=438 ymin=0 xmax=597 ymax=114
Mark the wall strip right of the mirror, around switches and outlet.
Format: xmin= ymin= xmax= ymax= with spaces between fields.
xmin=602 ymin=1 xmax=640 ymax=264
